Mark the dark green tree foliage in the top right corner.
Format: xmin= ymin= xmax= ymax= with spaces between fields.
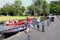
xmin=50 ymin=1 xmax=60 ymax=14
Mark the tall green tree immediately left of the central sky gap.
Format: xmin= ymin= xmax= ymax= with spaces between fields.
xmin=13 ymin=0 xmax=25 ymax=16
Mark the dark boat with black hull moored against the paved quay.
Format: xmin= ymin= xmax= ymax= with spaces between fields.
xmin=3 ymin=27 xmax=26 ymax=38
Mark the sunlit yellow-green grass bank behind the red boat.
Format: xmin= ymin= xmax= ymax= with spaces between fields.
xmin=0 ymin=16 xmax=34 ymax=22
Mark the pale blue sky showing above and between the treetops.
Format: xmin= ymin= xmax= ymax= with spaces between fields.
xmin=0 ymin=0 xmax=52 ymax=7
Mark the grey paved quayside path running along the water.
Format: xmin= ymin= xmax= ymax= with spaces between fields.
xmin=5 ymin=18 xmax=60 ymax=40
